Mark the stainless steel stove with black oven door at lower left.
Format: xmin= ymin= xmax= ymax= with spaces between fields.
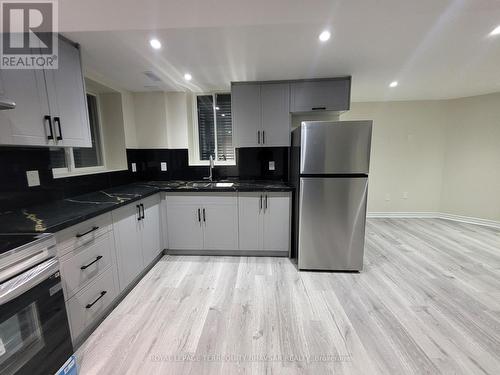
xmin=0 ymin=234 xmax=73 ymax=375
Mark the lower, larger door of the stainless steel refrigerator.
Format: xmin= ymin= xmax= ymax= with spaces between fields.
xmin=298 ymin=177 xmax=368 ymax=271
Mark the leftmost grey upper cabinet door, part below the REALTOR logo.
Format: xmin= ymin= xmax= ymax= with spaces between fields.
xmin=0 ymin=69 xmax=54 ymax=146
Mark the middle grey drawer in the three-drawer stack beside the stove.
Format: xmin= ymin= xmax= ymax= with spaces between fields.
xmin=61 ymin=232 xmax=114 ymax=299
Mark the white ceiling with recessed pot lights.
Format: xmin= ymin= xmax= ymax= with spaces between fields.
xmin=59 ymin=0 xmax=500 ymax=101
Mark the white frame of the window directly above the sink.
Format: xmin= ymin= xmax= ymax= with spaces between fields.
xmin=189 ymin=91 xmax=236 ymax=166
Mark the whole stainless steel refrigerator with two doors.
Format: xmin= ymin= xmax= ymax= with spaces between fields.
xmin=290 ymin=121 xmax=372 ymax=271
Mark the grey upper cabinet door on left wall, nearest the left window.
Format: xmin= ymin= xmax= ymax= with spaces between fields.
xmin=45 ymin=39 xmax=92 ymax=147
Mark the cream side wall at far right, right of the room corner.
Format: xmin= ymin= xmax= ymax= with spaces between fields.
xmin=441 ymin=93 xmax=500 ymax=221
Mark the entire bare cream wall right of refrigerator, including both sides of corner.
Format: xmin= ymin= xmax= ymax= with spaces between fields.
xmin=341 ymin=93 xmax=500 ymax=221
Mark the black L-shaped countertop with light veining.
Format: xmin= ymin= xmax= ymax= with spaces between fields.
xmin=0 ymin=181 xmax=292 ymax=233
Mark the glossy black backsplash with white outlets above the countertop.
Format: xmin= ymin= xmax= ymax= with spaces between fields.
xmin=0 ymin=146 xmax=289 ymax=211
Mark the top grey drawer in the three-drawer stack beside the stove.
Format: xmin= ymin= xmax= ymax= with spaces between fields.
xmin=56 ymin=213 xmax=112 ymax=256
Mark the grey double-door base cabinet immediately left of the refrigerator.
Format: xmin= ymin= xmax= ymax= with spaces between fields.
xmin=238 ymin=192 xmax=291 ymax=253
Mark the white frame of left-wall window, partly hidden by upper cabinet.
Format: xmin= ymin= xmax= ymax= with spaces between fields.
xmin=52 ymin=90 xmax=108 ymax=178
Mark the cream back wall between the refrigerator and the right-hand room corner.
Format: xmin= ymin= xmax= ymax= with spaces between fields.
xmin=341 ymin=101 xmax=446 ymax=212
